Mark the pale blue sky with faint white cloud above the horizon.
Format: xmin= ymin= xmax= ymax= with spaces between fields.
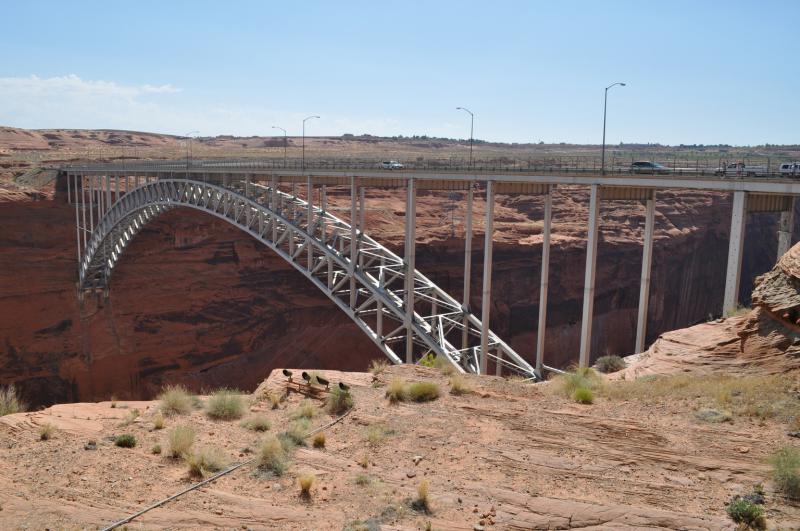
xmin=0 ymin=0 xmax=800 ymax=145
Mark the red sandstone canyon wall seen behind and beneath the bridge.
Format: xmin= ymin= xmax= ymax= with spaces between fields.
xmin=0 ymin=181 xmax=792 ymax=405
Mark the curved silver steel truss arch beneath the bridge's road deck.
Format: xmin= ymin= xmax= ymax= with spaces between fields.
xmin=76 ymin=178 xmax=537 ymax=378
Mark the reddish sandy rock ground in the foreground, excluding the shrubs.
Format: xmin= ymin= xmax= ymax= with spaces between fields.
xmin=0 ymin=366 xmax=800 ymax=530
